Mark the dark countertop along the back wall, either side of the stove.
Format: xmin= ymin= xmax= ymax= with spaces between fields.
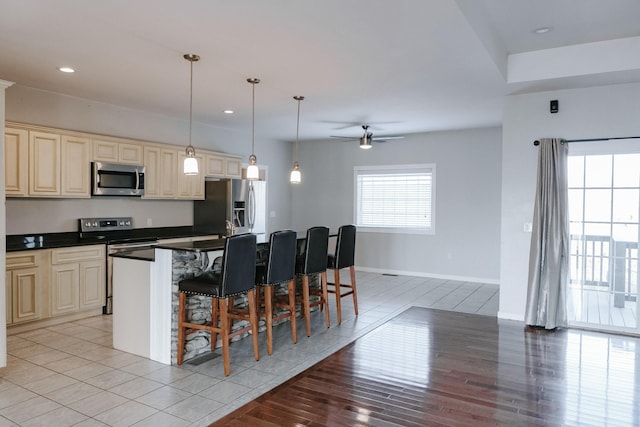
xmin=6 ymin=226 xmax=224 ymax=252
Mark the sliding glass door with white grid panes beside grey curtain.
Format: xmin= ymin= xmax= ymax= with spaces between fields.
xmin=567 ymin=139 xmax=640 ymax=333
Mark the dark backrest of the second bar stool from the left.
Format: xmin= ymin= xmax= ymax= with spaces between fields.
xmin=265 ymin=230 xmax=297 ymax=285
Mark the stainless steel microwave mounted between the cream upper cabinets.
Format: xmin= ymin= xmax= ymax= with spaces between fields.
xmin=91 ymin=162 xmax=144 ymax=196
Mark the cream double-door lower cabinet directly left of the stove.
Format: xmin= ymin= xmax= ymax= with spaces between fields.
xmin=50 ymin=245 xmax=106 ymax=316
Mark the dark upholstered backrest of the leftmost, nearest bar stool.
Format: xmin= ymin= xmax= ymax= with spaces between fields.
xmin=221 ymin=234 xmax=256 ymax=297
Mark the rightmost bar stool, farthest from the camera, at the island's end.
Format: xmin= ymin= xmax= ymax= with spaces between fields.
xmin=327 ymin=225 xmax=358 ymax=325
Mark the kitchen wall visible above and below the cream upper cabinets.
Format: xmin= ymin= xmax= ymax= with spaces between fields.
xmin=1 ymin=85 xmax=292 ymax=234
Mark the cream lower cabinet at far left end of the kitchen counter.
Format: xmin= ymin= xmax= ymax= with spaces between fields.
xmin=5 ymin=250 xmax=47 ymax=325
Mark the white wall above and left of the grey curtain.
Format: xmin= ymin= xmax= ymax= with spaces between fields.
xmin=498 ymin=84 xmax=640 ymax=321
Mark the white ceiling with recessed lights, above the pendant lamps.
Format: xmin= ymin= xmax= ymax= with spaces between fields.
xmin=0 ymin=0 xmax=640 ymax=141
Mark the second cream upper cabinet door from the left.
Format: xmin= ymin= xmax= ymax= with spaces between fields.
xmin=29 ymin=131 xmax=61 ymax=197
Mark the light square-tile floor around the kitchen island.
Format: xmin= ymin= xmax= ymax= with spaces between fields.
xmin=0 ymin=272 xmax=498 ymax=427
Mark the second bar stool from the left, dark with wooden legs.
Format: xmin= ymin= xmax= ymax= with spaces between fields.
xmin=256 ymin=230 xmax=298 ymax=355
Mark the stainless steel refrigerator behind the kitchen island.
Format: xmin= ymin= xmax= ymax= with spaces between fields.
xmin=193 ymin=179 xmax=267 ymax=234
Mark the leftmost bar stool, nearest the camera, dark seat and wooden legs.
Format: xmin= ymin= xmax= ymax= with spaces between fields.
xmin=178 ymin=234 xmax=260 ymax=376
